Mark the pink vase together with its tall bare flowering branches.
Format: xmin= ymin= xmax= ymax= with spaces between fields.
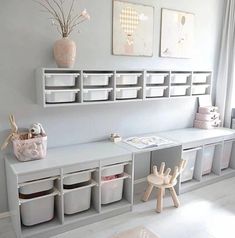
xmin=36 ymin=0 xmax=90 ymax=68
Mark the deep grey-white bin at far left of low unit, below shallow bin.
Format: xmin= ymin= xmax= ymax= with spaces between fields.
xmin=20 ymin=196 xmax=54 ymax=226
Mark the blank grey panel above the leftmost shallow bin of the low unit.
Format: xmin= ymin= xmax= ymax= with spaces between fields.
xmin=18 ymin=169 xmax=60 ymax=183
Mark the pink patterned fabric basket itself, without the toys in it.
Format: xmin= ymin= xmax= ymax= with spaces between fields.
xmin=12 ymin=136 xmax=47 ymax=161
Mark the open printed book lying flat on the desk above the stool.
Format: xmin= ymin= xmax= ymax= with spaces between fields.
xmin=124 ymin=136 xmax=173 ymax=149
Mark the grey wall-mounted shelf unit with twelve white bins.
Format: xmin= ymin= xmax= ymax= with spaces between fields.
xmin=36 ymin=68 xmax=212 ymax=107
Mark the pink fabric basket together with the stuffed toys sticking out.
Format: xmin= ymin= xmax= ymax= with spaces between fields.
xmin=1 ymin=115 xmax=47 ymax=161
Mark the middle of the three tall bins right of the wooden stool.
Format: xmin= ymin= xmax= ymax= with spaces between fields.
xmin=202 ymin=145 xmax=215 ymax=175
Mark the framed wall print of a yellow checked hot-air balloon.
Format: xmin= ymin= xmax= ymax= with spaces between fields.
xmin=113 ymin=0 xmax=154 ymax=56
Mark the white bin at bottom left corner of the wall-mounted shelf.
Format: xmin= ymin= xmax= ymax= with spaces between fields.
xmin=46 ymin=89 xmax=79 ymax=103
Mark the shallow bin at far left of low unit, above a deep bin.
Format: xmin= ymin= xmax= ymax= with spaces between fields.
xmin=19 ymin=180 xmax=54 ymax=195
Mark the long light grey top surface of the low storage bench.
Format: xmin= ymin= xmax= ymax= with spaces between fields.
xmin=6 ymin=128 xmax=235 ymax=174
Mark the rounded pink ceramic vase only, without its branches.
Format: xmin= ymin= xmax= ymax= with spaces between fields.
xmin=54 ymin=37 xmax=76 ymax=68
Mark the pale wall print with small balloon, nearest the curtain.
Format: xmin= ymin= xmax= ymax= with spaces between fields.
xmin=160 ymin=9 xmax=195 ymax=58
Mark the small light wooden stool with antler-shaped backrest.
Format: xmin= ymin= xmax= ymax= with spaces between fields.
xmin=143 ymin=160 xmax=186 ymax=213
